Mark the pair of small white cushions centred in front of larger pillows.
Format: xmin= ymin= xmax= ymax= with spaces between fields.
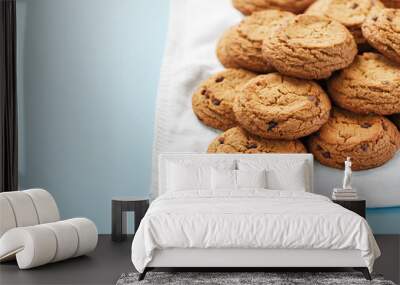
xmin=211 ymin=168 xmax=267 ymax=190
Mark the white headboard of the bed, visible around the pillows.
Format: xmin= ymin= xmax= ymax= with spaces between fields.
xmin=155 ymin=153 xmax=314 ymax=199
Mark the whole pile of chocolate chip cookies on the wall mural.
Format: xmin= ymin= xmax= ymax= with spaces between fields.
xmin=192 ymin=0 xmax=400 ymax=170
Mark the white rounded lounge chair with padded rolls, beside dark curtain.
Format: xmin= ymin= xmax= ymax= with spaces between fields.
xmin=0 ymin=189 xmax=97 ymax=269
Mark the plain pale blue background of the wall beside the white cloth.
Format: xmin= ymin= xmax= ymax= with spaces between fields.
xmin=17 ymin=0 xmax=400 ymax=233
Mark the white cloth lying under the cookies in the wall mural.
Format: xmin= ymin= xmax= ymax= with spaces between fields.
xmin=152 ymin=0 xmax=400 ymax=207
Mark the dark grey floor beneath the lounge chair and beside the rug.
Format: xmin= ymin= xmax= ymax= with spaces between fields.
xmin=0 ymin=235 xmax=400 ymax=285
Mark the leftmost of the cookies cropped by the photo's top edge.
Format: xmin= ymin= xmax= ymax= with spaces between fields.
xmin=232 ymin=0 xmax=315 ymax=15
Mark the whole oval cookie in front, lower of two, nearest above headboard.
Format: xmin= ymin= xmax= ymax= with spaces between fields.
xmin=233 ymin=73 xmax=331 ymax=139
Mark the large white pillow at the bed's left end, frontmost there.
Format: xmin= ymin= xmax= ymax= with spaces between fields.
xmin=167 ymin=163 xmax=211 ymax=191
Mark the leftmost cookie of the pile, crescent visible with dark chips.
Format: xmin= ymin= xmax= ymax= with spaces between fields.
xmin=192 ymin=69 xmax=256 ymax=130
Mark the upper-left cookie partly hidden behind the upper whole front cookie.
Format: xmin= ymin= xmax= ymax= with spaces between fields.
xmin=225 ymin=10 xmax=294 ymax=73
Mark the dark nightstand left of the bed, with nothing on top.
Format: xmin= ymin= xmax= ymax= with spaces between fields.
xmin=111 ymin=197 xmax=149 ymax=241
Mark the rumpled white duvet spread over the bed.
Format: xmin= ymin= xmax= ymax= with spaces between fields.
xmin=132 ymin=189 xmax=380 ymax=272
